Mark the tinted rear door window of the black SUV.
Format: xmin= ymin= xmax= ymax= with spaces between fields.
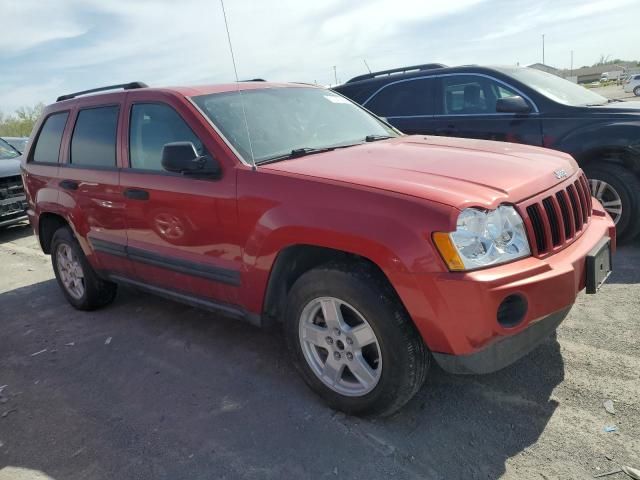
xmin=365 ymin=78 xmax=433 ymax=117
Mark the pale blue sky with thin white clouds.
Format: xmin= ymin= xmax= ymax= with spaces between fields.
xmin=0 ymin=0 xmax=640 ymax=114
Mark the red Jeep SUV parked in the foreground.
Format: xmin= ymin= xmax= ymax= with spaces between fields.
xmin=22 ymin=82 xmax=615 ymax=414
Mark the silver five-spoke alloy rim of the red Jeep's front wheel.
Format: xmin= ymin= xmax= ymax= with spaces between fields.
xmin=299 ymin=297 xmax=382 ymax=397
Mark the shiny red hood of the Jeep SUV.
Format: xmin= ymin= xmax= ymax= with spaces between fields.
xmin=259 ymin=136 xmax=578 ymax=208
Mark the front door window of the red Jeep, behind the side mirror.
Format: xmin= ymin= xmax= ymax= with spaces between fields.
xmin=129 ymin=103 xmax=206 ymax=171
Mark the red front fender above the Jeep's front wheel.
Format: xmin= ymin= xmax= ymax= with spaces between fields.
xmin=238 ymin=169 xmax=458 ymax=311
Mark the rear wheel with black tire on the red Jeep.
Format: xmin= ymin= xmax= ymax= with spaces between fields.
xmin=51 ymin=227 xmax=118 ymax=310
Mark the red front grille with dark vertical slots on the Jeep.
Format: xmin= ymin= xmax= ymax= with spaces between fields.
xmin=524 ymin=174 xmax=592 ymax=256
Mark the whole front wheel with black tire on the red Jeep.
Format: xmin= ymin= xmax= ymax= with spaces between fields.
xmin=285 ymin=264 xmax=431 ymax=416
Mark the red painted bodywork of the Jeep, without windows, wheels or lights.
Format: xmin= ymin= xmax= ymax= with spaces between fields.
xmin=23 ymin=82 xmax=615 ymax=354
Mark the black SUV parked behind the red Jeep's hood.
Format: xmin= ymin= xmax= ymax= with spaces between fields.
xmin=335 ymin=64 xmax=640 ymax=238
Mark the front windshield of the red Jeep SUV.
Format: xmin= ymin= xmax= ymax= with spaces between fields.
xmin=193 ymin=87 xmax=398 ymax=163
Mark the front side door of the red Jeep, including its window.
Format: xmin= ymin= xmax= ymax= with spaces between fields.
xmin=120 ymin=92 xmax=241 ymax=304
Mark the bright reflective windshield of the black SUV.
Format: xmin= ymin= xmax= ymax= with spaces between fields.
xmin=501 ymin=68 xmax=607 ymax=107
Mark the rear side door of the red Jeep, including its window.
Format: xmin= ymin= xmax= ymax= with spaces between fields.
xmin=58 ymin=94 xmax=131 ymax=275
